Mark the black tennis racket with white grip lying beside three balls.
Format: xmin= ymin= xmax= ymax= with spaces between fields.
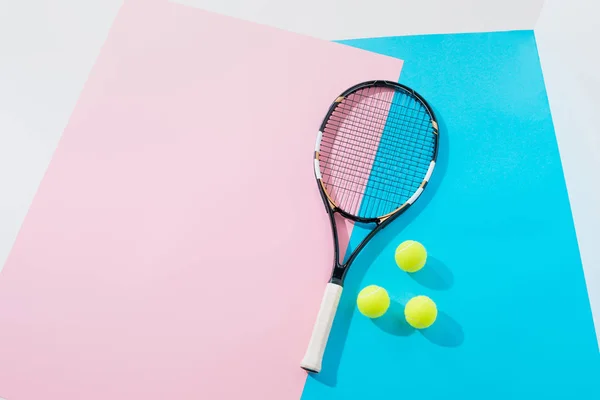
xmin=301 ymin=81 xmax=438 ymax=373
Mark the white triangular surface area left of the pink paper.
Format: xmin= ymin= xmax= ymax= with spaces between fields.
xmin=0 ymin=0 xmax=122 ymax=268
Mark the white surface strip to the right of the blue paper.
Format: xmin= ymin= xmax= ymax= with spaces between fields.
xmin=535 ymin=0 xmax=600 ymax=341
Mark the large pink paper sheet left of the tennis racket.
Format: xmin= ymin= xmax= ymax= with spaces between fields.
xmin=0 ymin=1 xmax=401 ymax=400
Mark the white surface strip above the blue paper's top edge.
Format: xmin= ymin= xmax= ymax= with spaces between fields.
xmin=173 ymin=0 xmax=543 ymax=40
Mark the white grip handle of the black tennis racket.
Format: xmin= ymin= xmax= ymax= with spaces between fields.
xmin=300 ymin=283 xmax=342 ymax=372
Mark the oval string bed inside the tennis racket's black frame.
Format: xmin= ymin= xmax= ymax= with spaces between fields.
xmin=319 ymin=88 xmax=436 ymax=218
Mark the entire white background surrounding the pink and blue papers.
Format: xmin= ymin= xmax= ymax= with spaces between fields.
xmin=0 ymin=0 xmax=600 ymax=340
